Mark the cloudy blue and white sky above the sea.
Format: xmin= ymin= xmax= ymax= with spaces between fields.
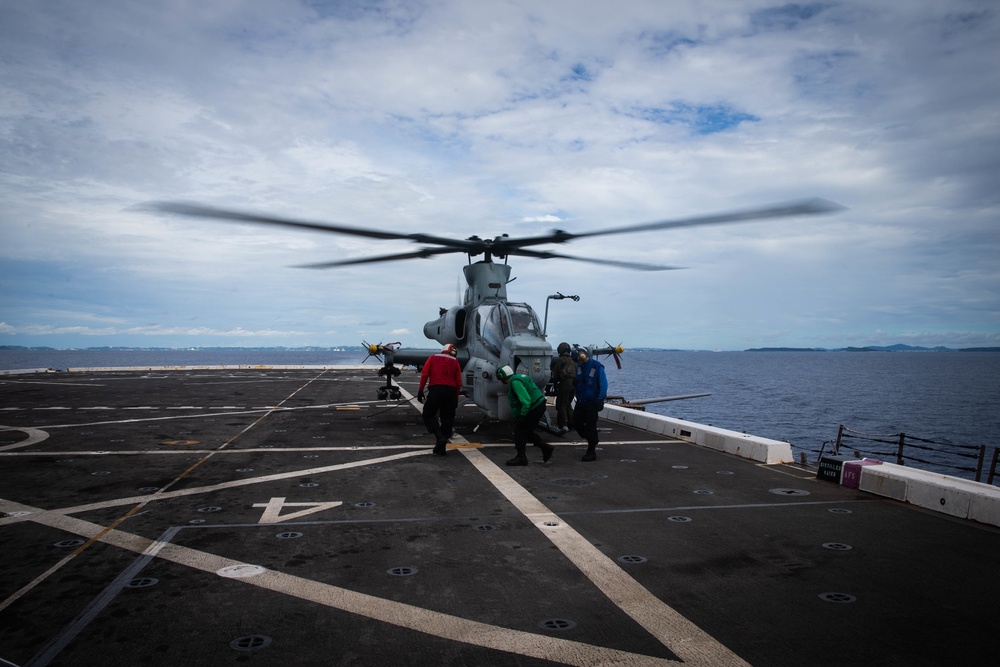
xmin=0 ymin=0 xmax=1000 ymax=350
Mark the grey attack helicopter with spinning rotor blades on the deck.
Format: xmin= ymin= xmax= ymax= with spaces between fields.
xmin=142 ymin=198 xmax=843 ymax=420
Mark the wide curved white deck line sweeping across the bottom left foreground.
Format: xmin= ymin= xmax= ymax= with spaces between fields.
xmin=0 ymin=499 xmax=680 ymax=667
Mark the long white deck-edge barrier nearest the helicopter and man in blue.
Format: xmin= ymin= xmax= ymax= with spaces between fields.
xmin=601 ymin=405 xmax=795 ymax=464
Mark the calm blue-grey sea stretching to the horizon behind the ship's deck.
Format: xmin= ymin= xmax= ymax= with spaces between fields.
xmin=0 ymin=350 xmax=1000 ymax=484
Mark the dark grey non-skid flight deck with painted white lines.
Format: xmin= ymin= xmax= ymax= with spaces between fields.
xmin=0 ymin=369 xmax=1000 ymax=667
